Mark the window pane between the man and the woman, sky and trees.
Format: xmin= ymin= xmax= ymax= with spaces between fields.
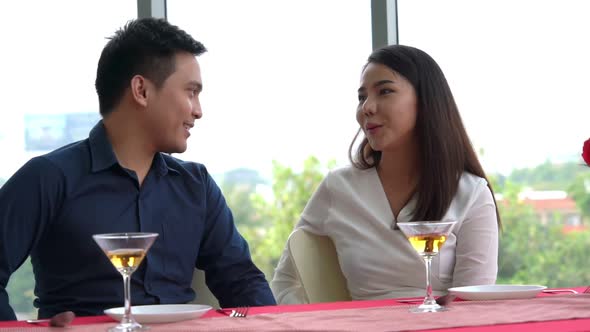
xmin=167 ymin=0 xmax=371 ymax=279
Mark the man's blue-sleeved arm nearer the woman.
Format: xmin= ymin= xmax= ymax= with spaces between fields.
xmin=196 ymin=167 xmax=276 ymax=307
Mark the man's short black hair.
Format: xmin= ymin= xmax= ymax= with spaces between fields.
xmin=95 ymin=18 xmax=207 ymax=117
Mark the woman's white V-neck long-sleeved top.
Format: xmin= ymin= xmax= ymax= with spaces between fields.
xmin=271 ymin=167 xmax=498 ymax=304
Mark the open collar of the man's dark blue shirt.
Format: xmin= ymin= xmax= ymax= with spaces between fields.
xmin=88 ymin=120 xmax=180 ymax=176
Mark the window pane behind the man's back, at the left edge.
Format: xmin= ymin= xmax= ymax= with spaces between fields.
xmin=0 ymin=0 xmax=137 ymax=318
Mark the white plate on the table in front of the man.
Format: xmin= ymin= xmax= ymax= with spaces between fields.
xmin=104 ymin=304 xmax=211 ymax=324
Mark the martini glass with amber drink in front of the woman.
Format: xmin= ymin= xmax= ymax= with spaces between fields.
xmin=397 ymin=221 xmax=456 ymax=312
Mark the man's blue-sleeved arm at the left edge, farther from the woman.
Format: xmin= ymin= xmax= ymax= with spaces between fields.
xmin=0 ymin=157 xmax=64 ymax=320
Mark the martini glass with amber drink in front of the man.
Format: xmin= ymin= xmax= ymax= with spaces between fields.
xmin=92 ymin=233 xmax=158 ymax=331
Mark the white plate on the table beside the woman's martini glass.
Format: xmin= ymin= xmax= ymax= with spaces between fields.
xmin=449 ymin=285 xmax=547 ymax=301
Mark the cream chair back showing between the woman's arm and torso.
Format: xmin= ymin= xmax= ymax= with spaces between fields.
xmin=287 ymin=229 xmax=351 ymax=303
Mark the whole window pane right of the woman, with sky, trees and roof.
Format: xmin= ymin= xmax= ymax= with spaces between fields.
xmin=398 ymin=0 xmax=590 ymax=287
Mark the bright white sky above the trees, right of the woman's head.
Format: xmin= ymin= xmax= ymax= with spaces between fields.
xmin=398 ymin=0 xmax=590 ymax=172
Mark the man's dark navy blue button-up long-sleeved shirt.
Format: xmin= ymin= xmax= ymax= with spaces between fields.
xmin=0 ymin=122 xmax=275 ymax=320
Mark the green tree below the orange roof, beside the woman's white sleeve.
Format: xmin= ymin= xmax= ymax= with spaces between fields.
xmin=498 ymin=182 xmax=590 ymax=287
